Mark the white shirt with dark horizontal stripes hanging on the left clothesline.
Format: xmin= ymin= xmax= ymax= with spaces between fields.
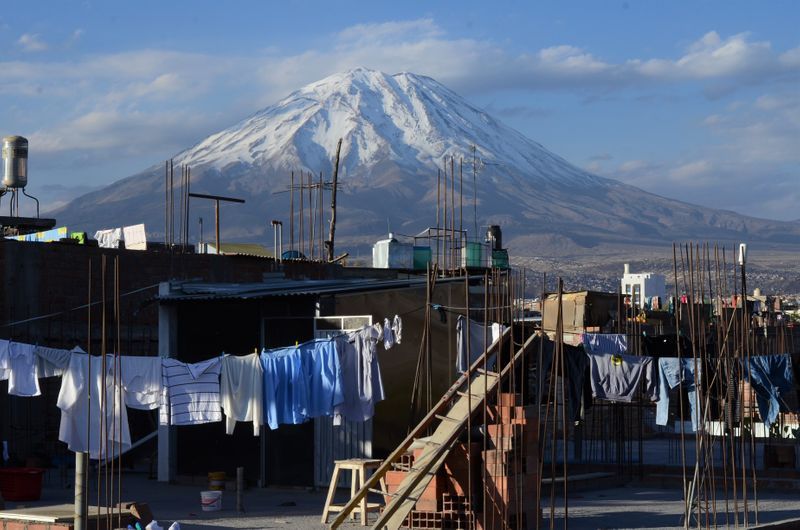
xmin=159 ymin=357 xmax=222 ymax=425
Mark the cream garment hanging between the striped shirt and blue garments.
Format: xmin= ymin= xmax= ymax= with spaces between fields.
xmin=220 ymin=353 xmax=264 ymax=436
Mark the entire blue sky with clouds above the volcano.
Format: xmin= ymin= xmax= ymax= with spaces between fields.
xmin=0 ymin=0 xmax=800 ymax=220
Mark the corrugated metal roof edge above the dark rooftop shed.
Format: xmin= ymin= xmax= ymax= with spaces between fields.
xmin=157 ymin=276 xmax=468 ymax=302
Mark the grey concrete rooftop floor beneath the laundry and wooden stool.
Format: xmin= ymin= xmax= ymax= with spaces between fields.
xmin=6 ymin=473 xmax=800 ymax=530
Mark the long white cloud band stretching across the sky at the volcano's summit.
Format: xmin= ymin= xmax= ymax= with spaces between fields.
xmin=0 ymin=23 xmax=800 ymax=105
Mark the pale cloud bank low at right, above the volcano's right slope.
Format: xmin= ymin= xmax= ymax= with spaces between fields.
xmin=597 ymin=92 xmax=800 ymax=220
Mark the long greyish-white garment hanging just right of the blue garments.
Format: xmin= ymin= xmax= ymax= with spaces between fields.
xmin=333 ymin=326 xmax=385 ymax=425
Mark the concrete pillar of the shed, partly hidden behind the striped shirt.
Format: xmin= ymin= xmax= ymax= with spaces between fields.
xmin=158 ymin=282 xmax=178 ymax=482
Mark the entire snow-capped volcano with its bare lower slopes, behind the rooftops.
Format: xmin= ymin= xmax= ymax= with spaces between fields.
xmin=55 ymin=68 xmax=800 ymax=255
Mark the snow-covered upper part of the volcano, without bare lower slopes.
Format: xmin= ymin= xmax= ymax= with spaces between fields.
xmin=176 ymin=68 xmax=602 ymax=186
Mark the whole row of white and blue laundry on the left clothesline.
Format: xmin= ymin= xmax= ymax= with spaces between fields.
xmin=0 ymin=316 xmax=402 ymax=459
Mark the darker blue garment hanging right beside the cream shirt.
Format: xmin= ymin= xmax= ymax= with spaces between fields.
xmin=261 ymin=346 xmax=309 ymax=429
